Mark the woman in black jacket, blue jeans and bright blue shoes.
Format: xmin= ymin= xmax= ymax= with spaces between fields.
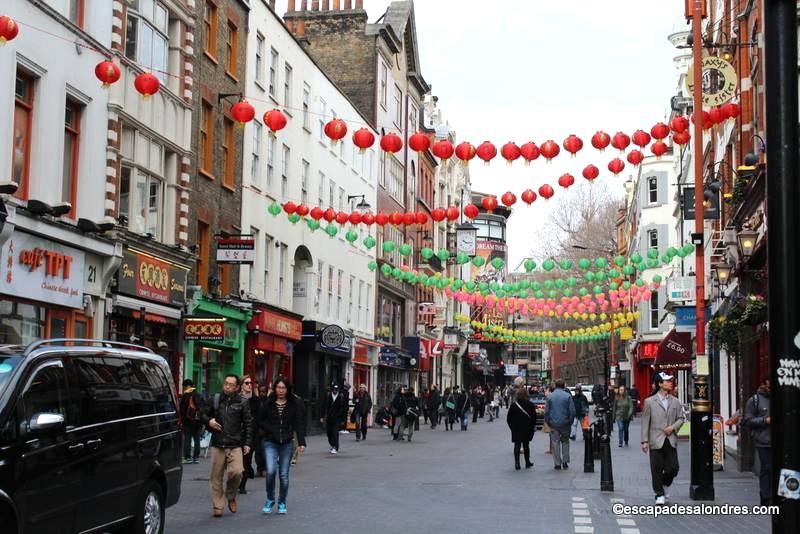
xmin=258 ymin=378 xmax=306 ymax=514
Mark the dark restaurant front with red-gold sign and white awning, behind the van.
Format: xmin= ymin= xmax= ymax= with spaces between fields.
xmin=108 ymin=243 xmax=189 ymax=388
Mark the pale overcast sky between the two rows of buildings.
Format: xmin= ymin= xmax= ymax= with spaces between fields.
xmin=278 ymin=0 xmax=688 ymax=269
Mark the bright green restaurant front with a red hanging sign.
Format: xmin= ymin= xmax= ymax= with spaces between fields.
xmin=183 ymin=296 xmax=251 ymax=395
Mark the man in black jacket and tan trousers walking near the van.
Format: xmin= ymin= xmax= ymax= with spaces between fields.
xmin=201 ymin=375 xmax=254 ymax=517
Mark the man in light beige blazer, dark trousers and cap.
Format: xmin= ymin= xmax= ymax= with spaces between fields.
xmin=642 ymin=371 xmax=685 ymax=504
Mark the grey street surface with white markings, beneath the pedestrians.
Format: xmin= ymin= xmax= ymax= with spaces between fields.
xmin=165 ymin=410 xmax=770 ymax=534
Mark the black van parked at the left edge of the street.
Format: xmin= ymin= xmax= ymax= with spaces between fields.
xmin=0 ymin=339 xmax=183 ymax=534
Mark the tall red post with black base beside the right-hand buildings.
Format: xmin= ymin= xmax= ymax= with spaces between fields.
xmin=686 ymin=0 xmax=714 ymax=501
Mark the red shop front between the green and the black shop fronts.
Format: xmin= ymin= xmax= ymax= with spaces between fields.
xmin=244 ymin=303 xmax=303 ymax=390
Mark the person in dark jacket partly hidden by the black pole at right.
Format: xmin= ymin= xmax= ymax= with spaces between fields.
xmin=743 ymin=378 xmax=774 ymax=506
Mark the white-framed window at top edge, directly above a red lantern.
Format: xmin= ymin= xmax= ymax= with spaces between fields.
xmin=125 ymin=0 xmax=169 ymax=83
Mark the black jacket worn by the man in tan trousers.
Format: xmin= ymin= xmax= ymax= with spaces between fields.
xmin=200 ymin=393 xmax=255 ymax=448
